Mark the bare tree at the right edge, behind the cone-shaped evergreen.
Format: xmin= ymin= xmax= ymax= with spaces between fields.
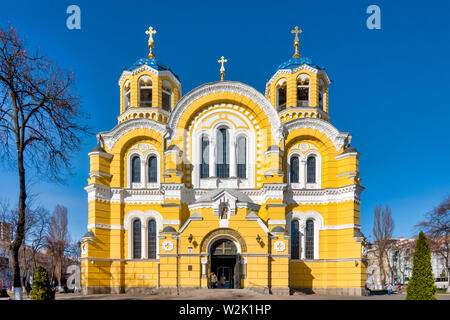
xmin=416 ymin=196 xmax=450 ymax=292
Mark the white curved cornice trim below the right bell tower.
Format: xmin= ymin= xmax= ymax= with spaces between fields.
xmin=284 ymin=118 xmax=351 ymax=152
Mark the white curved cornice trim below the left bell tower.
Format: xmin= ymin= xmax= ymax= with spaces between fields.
xmin=97 ymin=118 xmax=166 ymax=151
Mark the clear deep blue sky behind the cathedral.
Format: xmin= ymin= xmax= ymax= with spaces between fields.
xmin=0 ymin=0 xmax=450 ymax=242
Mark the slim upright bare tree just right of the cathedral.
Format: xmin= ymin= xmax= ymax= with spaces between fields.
xmin=373 ymin=205 xmax=394 ymax=286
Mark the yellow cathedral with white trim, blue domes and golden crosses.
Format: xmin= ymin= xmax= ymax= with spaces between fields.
xmin=81 ymin=27 xmax=366 ymax=295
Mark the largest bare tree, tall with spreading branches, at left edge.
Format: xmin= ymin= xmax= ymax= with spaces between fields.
xmin=0 ymin=26 xmax=88 ymax=298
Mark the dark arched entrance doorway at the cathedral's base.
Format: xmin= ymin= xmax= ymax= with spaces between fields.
xmin=209 ymin=238 xmax=241 ymax=289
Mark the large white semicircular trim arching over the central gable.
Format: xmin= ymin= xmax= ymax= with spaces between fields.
xmin=167 ymin=81 xmax=283 ymax=144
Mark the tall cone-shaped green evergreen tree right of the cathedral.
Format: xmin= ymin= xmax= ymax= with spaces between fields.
xmin=406 ymin=231 xmax=436 ymax=300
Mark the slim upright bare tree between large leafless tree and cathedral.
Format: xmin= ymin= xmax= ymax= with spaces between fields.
xmin=46 ymin=205 xmax=70 ymax=287
